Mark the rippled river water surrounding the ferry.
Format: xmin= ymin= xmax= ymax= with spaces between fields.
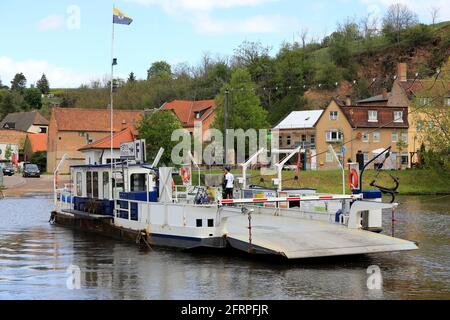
xmin=0 ymin=196 xmax=450 ymax=300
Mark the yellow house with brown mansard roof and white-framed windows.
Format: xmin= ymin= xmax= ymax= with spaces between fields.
xmin=315 ymin=98 xmax=409 ymax=169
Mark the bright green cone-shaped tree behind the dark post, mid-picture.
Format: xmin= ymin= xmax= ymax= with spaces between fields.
xmin=213 ymin=68 xmax=269 ymax=132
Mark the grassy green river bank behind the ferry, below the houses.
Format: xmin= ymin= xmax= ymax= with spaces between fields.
xmin=193 ymin=169 xmax=450 ymax=195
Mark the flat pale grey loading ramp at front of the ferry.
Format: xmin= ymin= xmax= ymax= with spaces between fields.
xmin=226 ymin=214 xmax=418 ymax=259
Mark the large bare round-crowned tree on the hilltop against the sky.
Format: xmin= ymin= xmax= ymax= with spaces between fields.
xmin=383 ymin=3 xmax=418 ymax=43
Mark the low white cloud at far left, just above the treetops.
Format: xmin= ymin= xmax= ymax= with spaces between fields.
xmin=0 ymin=56 xmax=103 ymax=88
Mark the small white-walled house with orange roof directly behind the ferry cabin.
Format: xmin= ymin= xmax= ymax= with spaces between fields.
xmin=78 ymin=127 xmax=137 ymax=164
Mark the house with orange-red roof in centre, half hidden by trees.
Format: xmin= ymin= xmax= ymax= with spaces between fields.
xmin=161 ymin=100 xmax=216 ymax=141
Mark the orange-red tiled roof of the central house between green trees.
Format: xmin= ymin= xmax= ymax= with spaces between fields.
xmin=161 ymin=100 xmax=216 ymax=127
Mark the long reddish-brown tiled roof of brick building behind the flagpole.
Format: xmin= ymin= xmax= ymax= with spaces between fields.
xmin=53 ymin=108 xmax=144 ymax=132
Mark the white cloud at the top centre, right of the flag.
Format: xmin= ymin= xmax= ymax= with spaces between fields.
xmin=127 ymin=0 xmax=300 ymax=35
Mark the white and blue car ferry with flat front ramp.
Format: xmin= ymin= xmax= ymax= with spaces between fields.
xmin=50 ymin=148 xmax=418 ymax=259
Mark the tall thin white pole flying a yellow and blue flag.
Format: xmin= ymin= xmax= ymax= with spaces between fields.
xmin=110 ymin=5 xmax=133 ymax=200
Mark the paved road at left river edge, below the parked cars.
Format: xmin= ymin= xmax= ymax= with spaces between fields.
xmin=3 ymin=174 xmax=69 ymax=198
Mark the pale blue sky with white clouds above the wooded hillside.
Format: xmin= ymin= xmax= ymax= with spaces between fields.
xmin=0 ymin=0 xmax=450 ymax=88
